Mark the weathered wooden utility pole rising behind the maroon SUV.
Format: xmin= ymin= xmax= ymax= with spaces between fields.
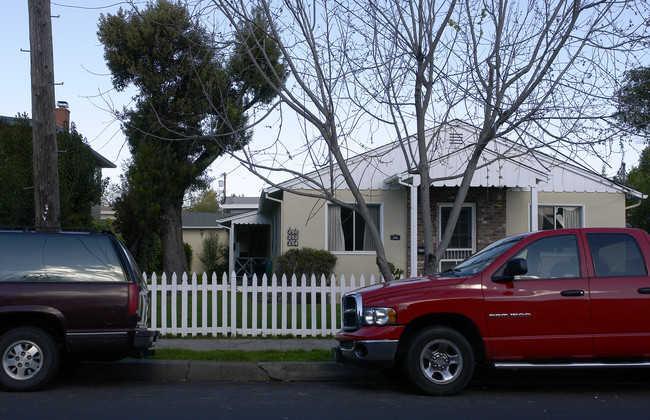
xmin=28 ymin=0 xmax=61 ymax=227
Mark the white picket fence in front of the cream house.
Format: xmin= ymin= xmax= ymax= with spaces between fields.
xmin=145 ymin=273 xmax=381 ymax=337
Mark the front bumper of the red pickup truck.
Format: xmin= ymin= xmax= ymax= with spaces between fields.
xmin=332 ymin=340 xmax=399 ymax=369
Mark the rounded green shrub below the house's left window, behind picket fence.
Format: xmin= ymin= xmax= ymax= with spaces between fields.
xmin=275 ymin=248 xmax=336 ymax=281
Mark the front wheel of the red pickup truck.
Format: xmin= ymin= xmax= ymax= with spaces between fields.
xmin=405 ymin=327 xmax=474 ymax=395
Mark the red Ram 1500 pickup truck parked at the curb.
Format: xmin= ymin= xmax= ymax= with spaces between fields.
xmin=334 ymin=228 xmax=650 ymax=395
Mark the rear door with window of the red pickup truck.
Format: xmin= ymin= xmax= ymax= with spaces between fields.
xmin=586 ymin=233 xmax=650 ymax=358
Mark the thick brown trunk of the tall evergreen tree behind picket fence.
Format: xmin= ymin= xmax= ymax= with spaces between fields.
xmin=160 ymin=202 xmax=189 ymax=283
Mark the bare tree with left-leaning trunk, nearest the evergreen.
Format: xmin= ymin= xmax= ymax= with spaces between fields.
xmin=213 ymin=0 xmax=393 ymax=280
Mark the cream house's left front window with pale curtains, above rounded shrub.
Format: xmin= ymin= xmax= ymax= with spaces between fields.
xmin=327 ymin=204 xmax=380 ymax=251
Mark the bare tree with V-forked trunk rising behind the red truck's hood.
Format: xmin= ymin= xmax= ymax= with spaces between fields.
xmin=351 ymin=0 xmax=647 ymax=274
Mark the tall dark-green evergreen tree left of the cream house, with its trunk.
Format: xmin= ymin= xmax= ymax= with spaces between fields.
xmin=98 ymin=0 xmax=285 ymax=274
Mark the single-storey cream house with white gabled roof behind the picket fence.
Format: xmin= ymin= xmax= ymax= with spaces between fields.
xmin=222 ymin=121 xmax=646 ymax=278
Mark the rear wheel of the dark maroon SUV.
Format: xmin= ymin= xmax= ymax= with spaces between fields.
xmin=0 ymin=327 xmax=61 ymax=391
